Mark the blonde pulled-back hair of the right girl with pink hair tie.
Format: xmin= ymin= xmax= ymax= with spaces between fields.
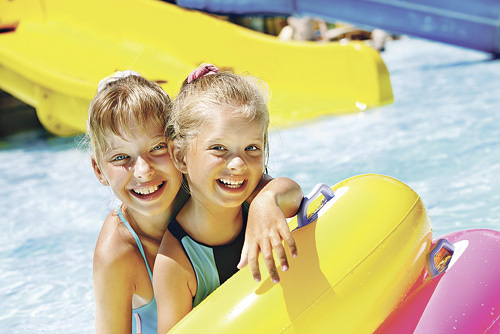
xmin=167 ymin=71 xmax=269 ymax=161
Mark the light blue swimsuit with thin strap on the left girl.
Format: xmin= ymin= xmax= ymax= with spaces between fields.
xmin=117 ymin=208 xmax=158 ymax=334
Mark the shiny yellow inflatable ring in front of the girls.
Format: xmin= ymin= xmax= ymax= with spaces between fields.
xmin=172 ymin=174 xmax=432 ymax=333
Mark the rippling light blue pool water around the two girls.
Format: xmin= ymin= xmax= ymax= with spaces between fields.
xmin=0 ymin=39 xmax=500 ymax=333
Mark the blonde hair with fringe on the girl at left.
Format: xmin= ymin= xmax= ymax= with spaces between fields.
xmin=87 ymin=74 xmax=172 ymax=162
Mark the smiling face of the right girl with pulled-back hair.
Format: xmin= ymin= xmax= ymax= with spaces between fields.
xmin=182 ymin=111 xmax=264 ymax=207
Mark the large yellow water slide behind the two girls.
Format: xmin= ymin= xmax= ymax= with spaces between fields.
xmin=0 ymin=0 xmax=393 ymax=136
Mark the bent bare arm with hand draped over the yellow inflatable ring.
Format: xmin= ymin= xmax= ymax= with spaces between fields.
xmin=238 ymin=175 xmax=303 ymax=283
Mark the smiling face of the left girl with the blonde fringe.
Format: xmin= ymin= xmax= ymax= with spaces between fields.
xmin=92 ymin=120 xmax=182 ymax=217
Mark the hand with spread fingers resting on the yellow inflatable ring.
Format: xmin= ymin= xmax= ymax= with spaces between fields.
xmin=238 ymin=193 xmax=297 ymax=283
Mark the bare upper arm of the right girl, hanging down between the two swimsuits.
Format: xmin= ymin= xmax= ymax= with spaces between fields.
xmin=153 ymin=232 xmax=196 ymax=333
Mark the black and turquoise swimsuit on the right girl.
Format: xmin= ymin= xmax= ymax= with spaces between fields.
xmin=168 ymin=209 xmax=247 ymax=307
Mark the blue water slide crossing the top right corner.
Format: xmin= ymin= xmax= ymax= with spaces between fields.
xmin=177 ymin=0 xmax=500 ymax=55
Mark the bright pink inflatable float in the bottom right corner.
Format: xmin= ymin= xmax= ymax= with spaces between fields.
xmin=376 ymin=229 xmax=500 ymax=334
